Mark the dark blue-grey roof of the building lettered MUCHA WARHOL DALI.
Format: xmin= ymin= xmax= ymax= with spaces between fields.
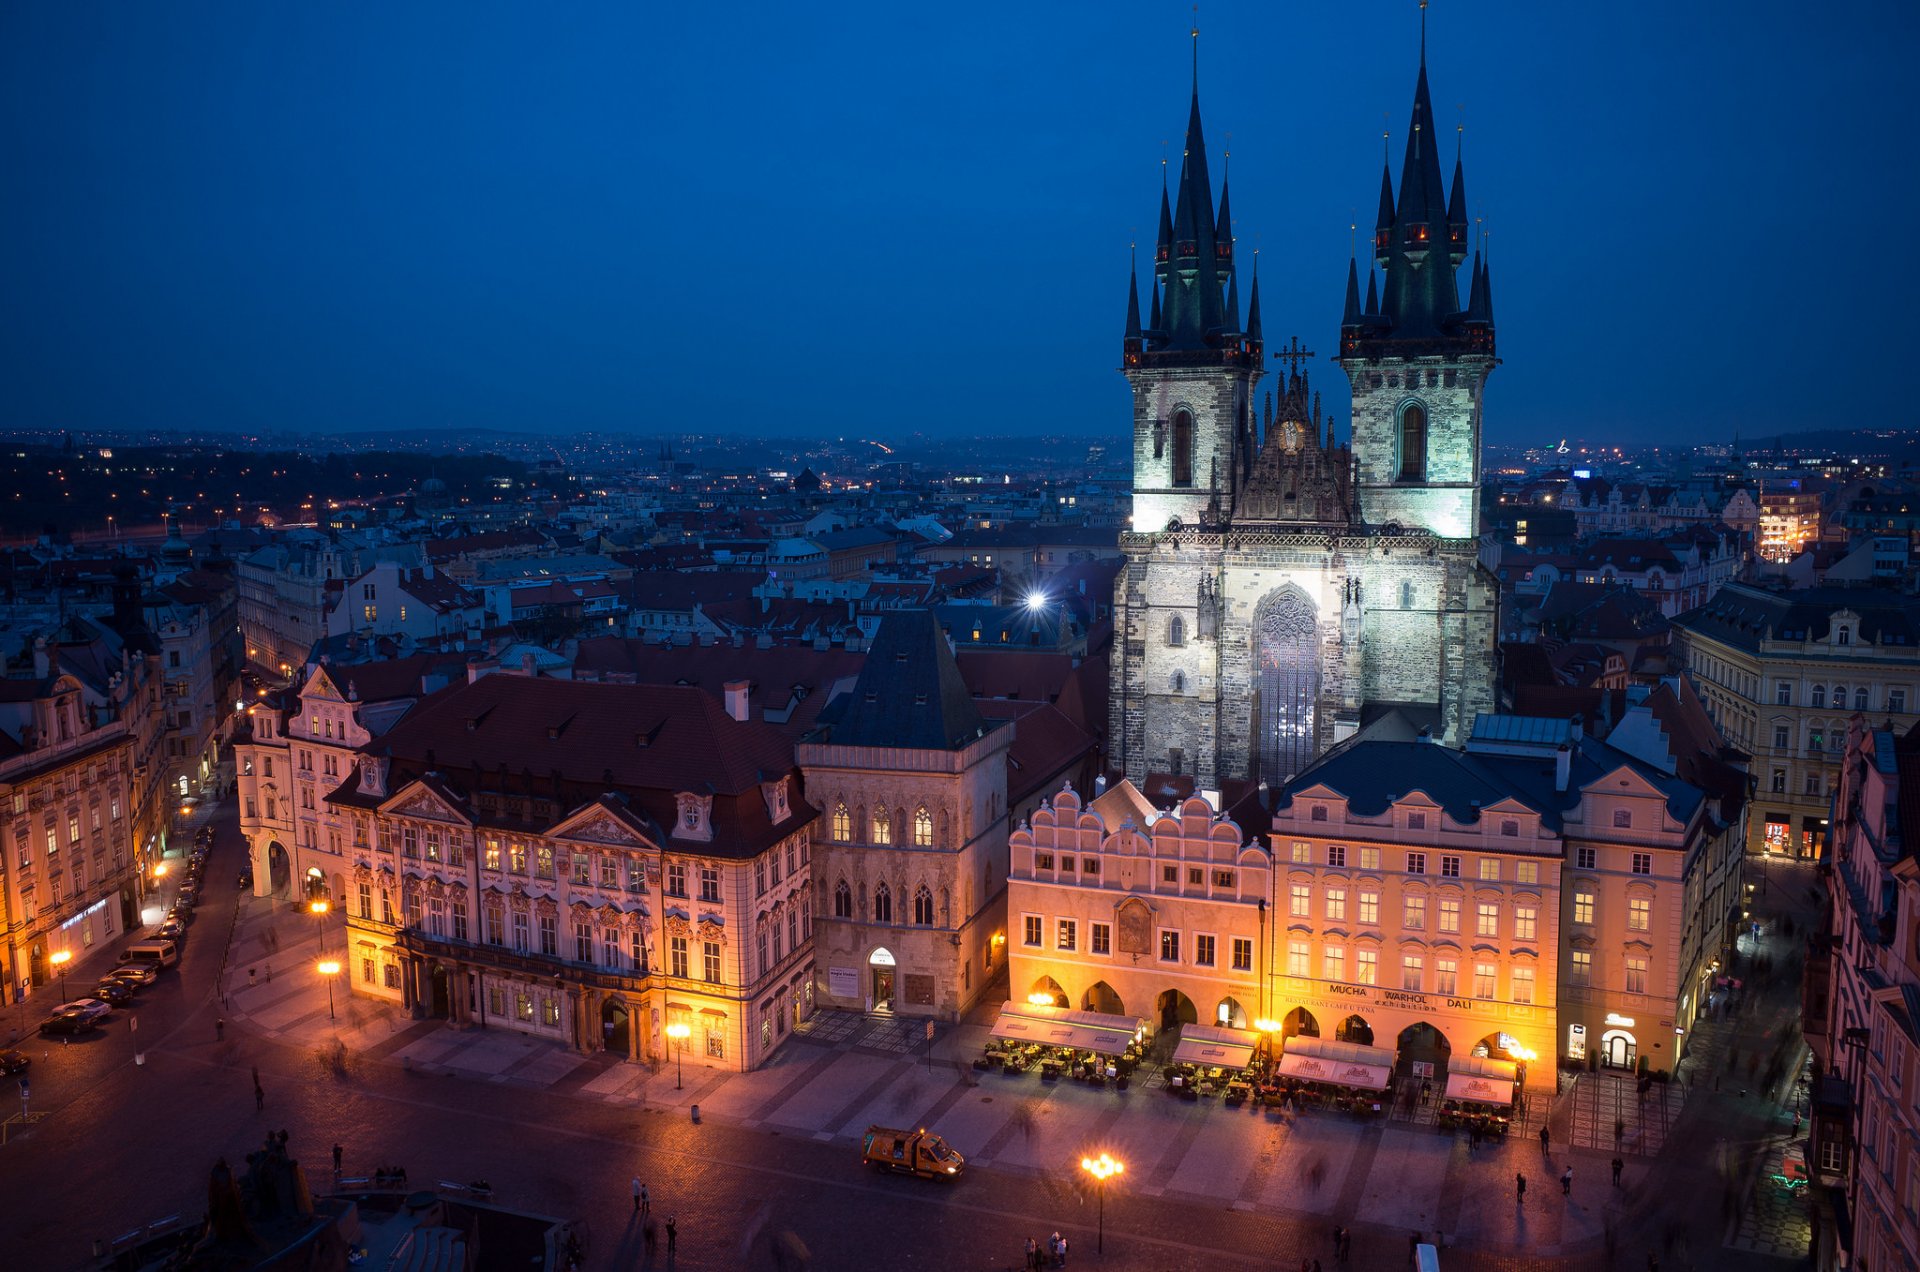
xmin=1273 ymin=736 xmax=1701 ymax=834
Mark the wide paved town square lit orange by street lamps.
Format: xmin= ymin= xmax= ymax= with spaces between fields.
xmin=0 ymin=807 xmax=1791 ymax=1272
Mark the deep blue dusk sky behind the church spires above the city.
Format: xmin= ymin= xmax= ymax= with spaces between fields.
xmin=0 ymin=0 xmax=1920 ymax=442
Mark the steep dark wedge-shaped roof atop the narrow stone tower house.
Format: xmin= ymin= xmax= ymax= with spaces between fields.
xmin=812 ymin=609 xmax=991 ymax=751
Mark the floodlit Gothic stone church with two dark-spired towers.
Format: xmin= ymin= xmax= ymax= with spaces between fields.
xmin=1108 ymin=22 xmax=1498 ymax=788
